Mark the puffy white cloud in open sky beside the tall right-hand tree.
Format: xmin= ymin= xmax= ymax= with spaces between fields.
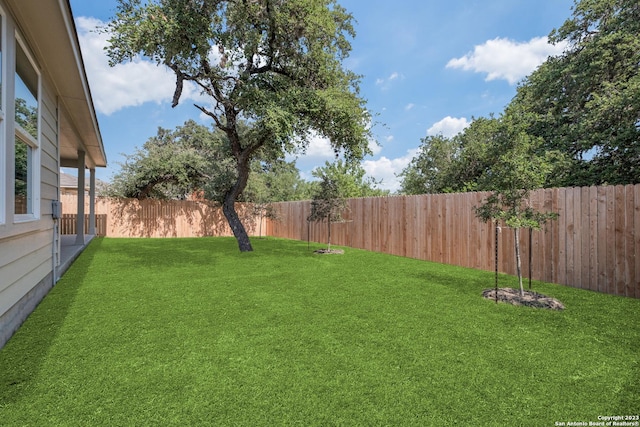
xmin=447 ymin=37 xmax=566 ymax=85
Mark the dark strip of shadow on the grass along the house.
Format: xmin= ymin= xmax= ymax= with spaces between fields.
xmin=0 ymin=238 xmax=102 ymax=406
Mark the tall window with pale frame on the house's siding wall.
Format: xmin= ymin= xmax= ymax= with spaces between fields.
xmin=14 ymin=38 xmax=40 ymax=221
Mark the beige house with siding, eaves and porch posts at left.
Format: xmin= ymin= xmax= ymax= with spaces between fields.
xmin=0 ymin=0 xmax=107 ymax=348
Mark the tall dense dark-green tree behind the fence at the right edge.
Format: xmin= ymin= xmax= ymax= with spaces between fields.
xmin=508 ymin=0 xmax=640 ymax=186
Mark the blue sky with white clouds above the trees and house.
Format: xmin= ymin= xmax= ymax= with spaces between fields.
xmin=71 ymin=0 xmax=573 ymax=191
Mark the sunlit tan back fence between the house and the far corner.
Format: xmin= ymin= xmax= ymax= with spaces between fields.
xmin=61 ymin=195 xmax=266 ymax=237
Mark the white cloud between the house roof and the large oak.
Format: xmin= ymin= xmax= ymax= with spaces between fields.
xmin=76 ymin=17 xmax=205 ymax=115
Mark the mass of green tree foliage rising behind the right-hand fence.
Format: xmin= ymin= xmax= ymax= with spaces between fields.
xmin=401 ymin=0 xmax=640 ymax=194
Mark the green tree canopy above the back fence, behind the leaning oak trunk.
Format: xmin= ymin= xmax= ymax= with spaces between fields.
xmin=106 ymin=120 xmax=311 ymax=204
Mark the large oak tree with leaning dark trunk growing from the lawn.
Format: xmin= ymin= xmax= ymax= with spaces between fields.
xmin=106 ymin=0 xmax=369 ymax=251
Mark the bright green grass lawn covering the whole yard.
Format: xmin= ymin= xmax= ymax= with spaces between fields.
xmin=0 ymin=238 xmax=640 ymax=426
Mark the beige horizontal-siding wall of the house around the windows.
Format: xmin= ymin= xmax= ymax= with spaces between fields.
xmin=0 ymin=0 xmax=60 ymax=347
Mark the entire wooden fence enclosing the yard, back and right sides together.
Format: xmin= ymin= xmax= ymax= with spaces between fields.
xmin=61 ymin=185 xmax=640 ymax=298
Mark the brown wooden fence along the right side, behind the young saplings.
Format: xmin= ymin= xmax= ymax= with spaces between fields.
xmin=267 ymin=185 xmax=640 ymax=298
